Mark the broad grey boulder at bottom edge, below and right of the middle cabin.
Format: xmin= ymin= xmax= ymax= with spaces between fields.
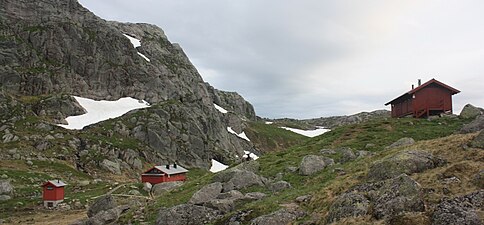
xmin=156 ymin=204 xmax=221 ymax=225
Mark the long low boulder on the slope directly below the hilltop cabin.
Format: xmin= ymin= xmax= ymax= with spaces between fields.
xmin=368 ymin=150 xmax=445 ymax=181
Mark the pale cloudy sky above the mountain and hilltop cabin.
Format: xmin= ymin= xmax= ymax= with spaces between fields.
xmin=79 ymin=0 xmax=484 ymax=119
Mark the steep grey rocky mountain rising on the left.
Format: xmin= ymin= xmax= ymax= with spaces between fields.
xmin=0 ymin=0 xmax=255 ymax=171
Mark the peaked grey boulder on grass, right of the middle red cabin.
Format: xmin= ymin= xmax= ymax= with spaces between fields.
xmin=223 ymin=170 xmax=264 ymax=192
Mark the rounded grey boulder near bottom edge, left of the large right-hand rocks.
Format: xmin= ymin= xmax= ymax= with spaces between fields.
xmin=327 ymin=193 xmax=370 ymax=223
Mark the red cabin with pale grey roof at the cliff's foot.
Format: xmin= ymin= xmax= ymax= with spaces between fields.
xmin=141 ymin=163 xmax=188 ymax=184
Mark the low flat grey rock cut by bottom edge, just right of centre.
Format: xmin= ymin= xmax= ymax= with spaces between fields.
xmin=250 ymin=209 xmax=305 ymax=225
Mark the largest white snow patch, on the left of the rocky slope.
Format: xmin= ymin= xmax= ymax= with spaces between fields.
xmin=59 ymin=96 xmax=149 ymax=130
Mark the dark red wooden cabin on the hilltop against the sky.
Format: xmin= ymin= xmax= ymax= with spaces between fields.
xmin=385 ymin=79 xmax=460 ymax=118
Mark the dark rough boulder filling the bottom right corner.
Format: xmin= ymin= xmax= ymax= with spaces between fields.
xmin=432 ymin=189 xmax=484 ymax=225
